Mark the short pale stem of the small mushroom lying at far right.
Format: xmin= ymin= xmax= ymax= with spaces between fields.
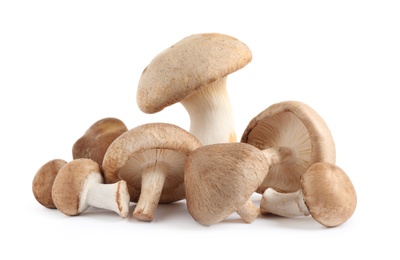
xmin=260 ymin=188 xmax=310 ymax=217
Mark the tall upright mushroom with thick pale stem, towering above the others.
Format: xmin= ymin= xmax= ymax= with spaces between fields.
xmin=136 ymin=33 xmax=252 ymax=145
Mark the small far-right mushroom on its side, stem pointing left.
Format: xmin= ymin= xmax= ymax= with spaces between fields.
xmin=260 ymin=162 xmax=357 ymax=227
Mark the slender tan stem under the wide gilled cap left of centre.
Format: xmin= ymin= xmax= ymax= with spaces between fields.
xmin=133 ymin=162 xmax=167 ymax=222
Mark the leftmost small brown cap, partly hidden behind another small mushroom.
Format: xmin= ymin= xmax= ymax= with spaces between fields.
xmin=32 ymin=159 xmax=67 ymax=209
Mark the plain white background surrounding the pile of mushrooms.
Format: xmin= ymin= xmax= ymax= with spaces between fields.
xmin=0 ymin=0 xmax=400 ymax=259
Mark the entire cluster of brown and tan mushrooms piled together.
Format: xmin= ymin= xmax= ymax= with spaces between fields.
xmin=32 ymin=33 xmax=357 ymax=227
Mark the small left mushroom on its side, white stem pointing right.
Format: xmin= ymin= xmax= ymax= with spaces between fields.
xmin=52 ymin=158 xmax=130 ymax=218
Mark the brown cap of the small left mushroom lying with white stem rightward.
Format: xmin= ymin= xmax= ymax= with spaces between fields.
xmin=52 ymin=158 xmax=103 ymax=216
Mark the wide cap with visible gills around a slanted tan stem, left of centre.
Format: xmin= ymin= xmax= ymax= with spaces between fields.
xmin=102 ymin=123 xmax=201 ymax=203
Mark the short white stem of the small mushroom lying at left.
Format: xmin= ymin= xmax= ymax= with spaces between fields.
xmin=78 ymin=173 xmax=130 ymax=218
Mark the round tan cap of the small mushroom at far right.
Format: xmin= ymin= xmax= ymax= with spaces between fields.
xmin=301 ymin=162 xmax=357 ymax=227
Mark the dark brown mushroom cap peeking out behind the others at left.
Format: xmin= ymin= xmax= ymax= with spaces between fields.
xmin=72 ymin=117 xmax=128 ymax=165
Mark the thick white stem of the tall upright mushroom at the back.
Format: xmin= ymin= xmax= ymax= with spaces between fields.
xmin=181 ymin=77 xmax=236 ymax=145
